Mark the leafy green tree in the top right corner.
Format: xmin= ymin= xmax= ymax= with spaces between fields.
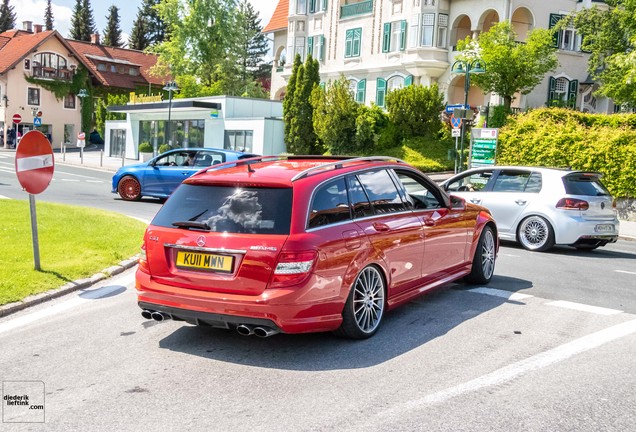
xmin=568 ymin=0 xmax=636 ymax=107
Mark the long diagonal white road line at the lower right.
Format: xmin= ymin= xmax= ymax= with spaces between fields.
xmin=379 ymin=320 xmax=636 ymax=416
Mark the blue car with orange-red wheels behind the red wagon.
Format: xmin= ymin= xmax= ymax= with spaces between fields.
xmin=112 ymin=148 xmax=257 ymax=201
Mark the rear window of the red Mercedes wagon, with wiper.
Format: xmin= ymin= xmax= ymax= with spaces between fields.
xmin=152 ymin=184 xmax=292 ymax=234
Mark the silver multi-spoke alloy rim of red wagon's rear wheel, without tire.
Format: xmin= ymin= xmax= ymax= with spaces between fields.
xmin=353 ymin=267 xmax=384 ymax=333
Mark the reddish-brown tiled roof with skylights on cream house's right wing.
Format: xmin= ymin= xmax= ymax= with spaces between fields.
xmin=67 ymin=40 xmax=169 ymax=89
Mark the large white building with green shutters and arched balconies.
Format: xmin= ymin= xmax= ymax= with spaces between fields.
xmin=271 ymin=0 xmax=613 ymax=112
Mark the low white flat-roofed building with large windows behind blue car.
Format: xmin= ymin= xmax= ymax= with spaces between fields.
xmin=104 ymin=96 xmax=285 ymax=159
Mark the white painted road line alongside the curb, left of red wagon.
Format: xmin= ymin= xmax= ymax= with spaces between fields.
xmin=0 ymin=272 xmax=135 ymax=334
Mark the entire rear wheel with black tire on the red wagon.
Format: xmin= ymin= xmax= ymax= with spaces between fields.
xmin=334 ymin=266 xmax=386 ymax=339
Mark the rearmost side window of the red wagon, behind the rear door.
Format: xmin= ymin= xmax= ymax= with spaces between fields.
xmin=307 ymin=178 xmax=351 ymax=228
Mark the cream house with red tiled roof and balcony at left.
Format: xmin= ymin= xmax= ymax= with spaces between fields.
xmin=0 ymin=21 xmax=166 ymax=148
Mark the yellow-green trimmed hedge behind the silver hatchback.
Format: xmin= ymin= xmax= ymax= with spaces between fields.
xmin=497 ymin=108 xmax=636 ymax=198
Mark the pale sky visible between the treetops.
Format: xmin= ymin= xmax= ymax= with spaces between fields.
xmin=9 ymin=0 xmax=278 ymax=41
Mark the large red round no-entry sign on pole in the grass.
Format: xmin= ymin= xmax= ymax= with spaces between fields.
xmin=15 ymin=130 xmax=55 ymax=195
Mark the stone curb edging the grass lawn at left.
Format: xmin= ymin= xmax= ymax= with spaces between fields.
xmin=0 ymin=256 xmax=138 ymax=318
